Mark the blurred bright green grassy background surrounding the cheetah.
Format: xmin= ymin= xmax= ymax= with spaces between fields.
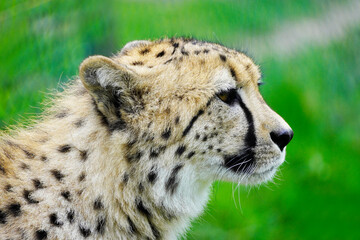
xmin=0 ymin=0 xmax=360 ymax=239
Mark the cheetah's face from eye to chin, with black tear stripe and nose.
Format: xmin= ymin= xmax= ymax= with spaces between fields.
xmin=187 ymin=68 xmax=293 ymax=184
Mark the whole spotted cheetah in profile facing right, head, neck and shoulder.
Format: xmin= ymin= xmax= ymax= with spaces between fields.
xmin=0 ymin=38 xmax=293 ymax=240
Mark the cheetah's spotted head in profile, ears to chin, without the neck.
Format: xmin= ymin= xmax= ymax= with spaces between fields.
xmin=80 ymin=39 xmax=293 ymax=188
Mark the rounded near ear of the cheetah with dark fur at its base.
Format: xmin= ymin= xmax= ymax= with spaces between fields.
xmin=79 ymin=56 xmax=139 ymax=129
